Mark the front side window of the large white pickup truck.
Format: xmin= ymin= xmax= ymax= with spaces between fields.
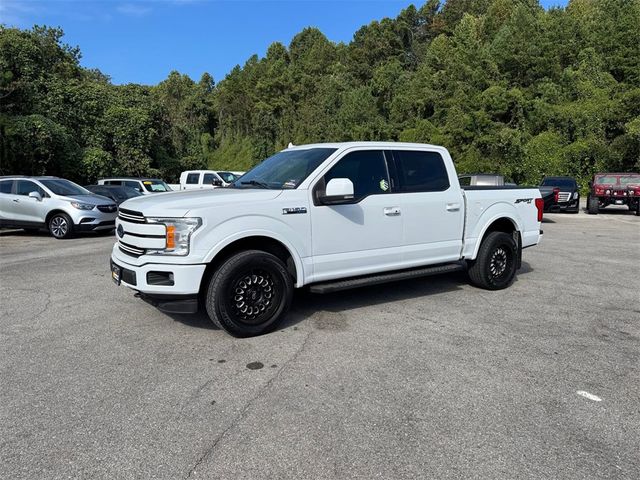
xmin=324 ymin=150 xmax=391 ymax=202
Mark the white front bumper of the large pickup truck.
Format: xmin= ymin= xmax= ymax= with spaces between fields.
xmin=111 ymin=244 xmax=207 ymax=296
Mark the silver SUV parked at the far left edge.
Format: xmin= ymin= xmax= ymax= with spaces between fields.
xmin=0 ymin=176 xmax=118 ymax=238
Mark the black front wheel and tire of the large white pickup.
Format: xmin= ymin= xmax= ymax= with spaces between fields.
xmin=205 ymin=250 xmax=293 ymax=337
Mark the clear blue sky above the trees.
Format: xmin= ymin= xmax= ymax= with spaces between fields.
xmin=0 ymin=0 xmax=567 ymax=84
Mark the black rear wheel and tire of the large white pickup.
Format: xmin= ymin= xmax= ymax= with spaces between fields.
xmin=469 ymin=232 xmax=518 ymax=290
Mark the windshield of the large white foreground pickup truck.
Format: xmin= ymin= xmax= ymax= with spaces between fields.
xmin=232 ymin=148 xmax=336 ymax=190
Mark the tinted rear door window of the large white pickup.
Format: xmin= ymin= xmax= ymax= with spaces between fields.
xmin=393 ymin=150 xmax=449 ymax=192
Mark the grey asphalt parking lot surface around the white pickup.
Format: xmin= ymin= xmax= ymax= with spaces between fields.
xmin=0 ymin=210 xmax=640 ymax=479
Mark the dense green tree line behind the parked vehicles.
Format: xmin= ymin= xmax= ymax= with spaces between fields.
xmin=0 ymin=0 xmax=640 ymax=184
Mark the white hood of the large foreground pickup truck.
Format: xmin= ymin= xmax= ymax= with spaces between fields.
xmin=120 ymin=188 xmax=282 ymax=217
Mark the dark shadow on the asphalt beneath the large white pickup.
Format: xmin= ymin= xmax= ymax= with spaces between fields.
xmin=165 ymin=262 xmax=533 ymax=330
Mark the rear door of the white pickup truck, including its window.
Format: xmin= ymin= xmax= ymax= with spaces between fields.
xmin=392 ymin=149 xmax=464 ymax=266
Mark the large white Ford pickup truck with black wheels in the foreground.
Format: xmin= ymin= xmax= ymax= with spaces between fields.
xmin=111 ymin=142 xmax=543 ymax=336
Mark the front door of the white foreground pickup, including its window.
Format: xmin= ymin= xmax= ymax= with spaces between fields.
xmin=310 ymin=150 xmax=403 ymax=281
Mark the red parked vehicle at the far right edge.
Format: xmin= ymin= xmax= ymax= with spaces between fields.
xmin=587 ymin=173 xmax=640 ymax=216
